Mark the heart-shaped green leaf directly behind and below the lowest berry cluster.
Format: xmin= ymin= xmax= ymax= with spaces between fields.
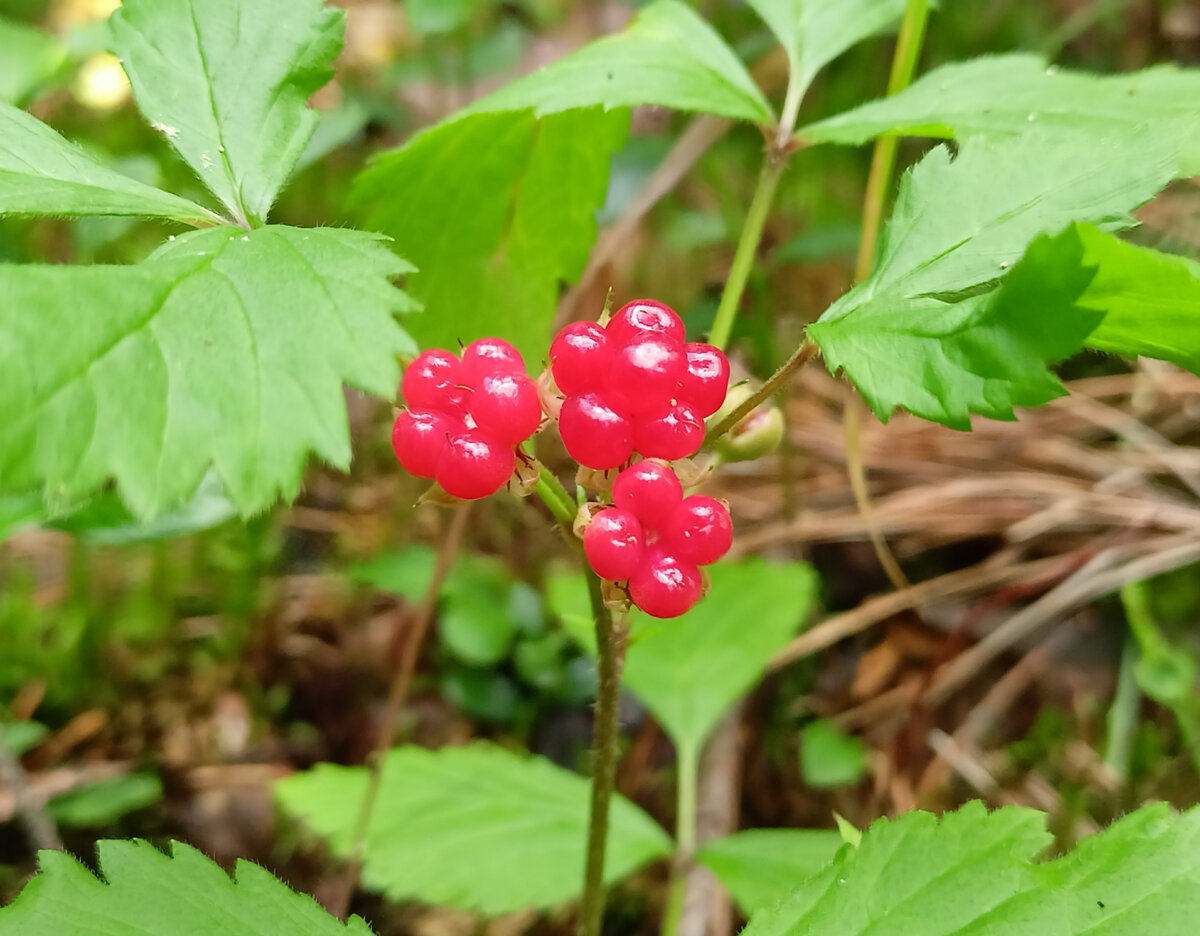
xmin=547 ymin=558 xmax=817 ymax=751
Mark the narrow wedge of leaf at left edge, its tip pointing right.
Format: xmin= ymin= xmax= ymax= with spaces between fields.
xmin=0 ymin=102 xmax=216 ymax=224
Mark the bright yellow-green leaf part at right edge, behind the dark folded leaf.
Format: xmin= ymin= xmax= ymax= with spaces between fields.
xmin=1079 ymin=226 xmax=1200 ymax=373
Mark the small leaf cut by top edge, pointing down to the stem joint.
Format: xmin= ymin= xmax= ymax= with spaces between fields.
xmin=748 ymin=0 xmax=905 ymax=88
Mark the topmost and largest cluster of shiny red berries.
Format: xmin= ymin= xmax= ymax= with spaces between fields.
xmin=550 ymin=299 xmax=730 ymax=470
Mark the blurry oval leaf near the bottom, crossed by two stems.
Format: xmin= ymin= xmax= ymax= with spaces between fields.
xmin=275 ymin=744 xmax=671 ymax=914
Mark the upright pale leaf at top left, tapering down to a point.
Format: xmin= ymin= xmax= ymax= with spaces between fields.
xmin=110 ymin=0 xmax=344 ymax=223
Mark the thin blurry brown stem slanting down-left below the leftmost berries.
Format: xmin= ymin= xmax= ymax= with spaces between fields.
xmin=329 ymin=503 xmax=470 ymax=919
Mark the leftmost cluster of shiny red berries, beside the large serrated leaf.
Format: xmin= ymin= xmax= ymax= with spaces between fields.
xmin=391 ymin=338 xmax=541 ymax=500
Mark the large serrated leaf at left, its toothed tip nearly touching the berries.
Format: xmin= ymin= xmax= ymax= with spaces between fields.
xmin=0 ymin=227 xmax=413 ymax=520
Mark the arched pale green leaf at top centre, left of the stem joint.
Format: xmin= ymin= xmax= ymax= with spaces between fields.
xmin=466 ymin=0 xmax=773 ymax=124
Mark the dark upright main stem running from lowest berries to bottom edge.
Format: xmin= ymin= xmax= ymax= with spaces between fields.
xmin=580 ymin=578 xmax=628 ymax=936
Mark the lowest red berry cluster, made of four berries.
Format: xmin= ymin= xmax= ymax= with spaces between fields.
xmin=583 ymin=461 xmax=733 ymax=618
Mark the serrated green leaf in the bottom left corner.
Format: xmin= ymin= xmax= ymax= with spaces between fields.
xmin=0 ymin=840 xmax=371 ymax=936
